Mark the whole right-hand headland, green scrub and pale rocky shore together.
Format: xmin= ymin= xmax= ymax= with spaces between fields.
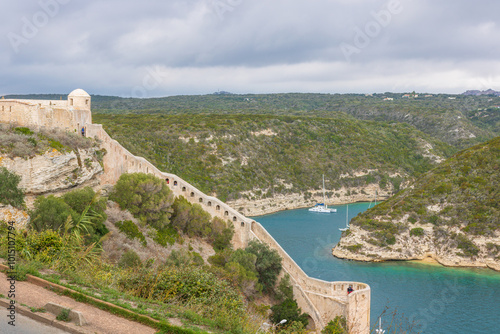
xmin=334 ymin=137 xmax=500 ymax=270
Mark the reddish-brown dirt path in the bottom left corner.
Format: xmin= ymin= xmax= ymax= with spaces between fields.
xmin=0 ymin=272 xmax=156 ymax=334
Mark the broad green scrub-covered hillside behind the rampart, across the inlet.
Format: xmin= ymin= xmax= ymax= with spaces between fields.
xmin=94 ymin=114 xmax=455 ymax=200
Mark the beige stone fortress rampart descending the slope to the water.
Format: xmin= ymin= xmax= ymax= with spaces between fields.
xmin=0 ymin=93 xmax=371 ymax=334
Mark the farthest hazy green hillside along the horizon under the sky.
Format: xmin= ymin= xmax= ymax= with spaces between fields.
xmin=6 ymin=92 xmax=500 ymax=148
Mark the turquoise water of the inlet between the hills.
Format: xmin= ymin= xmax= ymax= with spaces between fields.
xmin=254 ymin=203 xmax=500 ymax=334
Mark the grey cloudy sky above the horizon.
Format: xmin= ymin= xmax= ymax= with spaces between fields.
xmin=0 ymin=0 xmax=500 ymax=97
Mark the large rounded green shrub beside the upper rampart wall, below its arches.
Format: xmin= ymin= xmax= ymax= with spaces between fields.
xmin=110 ymin=173 xmax=174 ymax=229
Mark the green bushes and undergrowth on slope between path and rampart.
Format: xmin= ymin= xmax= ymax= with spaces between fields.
xmin=0 ymin=173 xmax=307 ymax=334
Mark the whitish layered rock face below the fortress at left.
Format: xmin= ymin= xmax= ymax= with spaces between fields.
xmin=0 ymin=149 xmax=103 ymax=196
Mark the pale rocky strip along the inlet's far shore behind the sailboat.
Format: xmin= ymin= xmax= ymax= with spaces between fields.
xmin=227 ymin=184 xmax=392 ymax=216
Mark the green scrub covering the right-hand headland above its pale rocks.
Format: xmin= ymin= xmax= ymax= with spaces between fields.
xmin=351 ymin=137 xmax=500 ymax=256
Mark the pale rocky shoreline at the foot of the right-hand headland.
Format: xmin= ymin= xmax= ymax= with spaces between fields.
xmin=332 ymin=224 xmax=500 ymax=271
